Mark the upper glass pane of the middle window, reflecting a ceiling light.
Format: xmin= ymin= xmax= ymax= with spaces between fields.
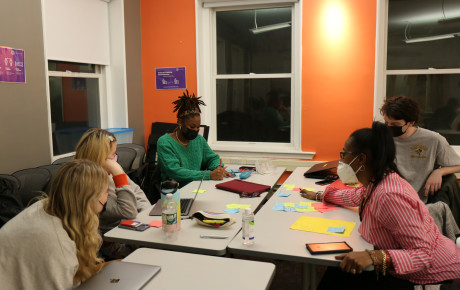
xmin=216 ymin=7 xmax=292 ymax=74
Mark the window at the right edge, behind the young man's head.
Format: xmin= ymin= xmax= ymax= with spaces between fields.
xmin=376 ymin=0 xmax=460 ymax=145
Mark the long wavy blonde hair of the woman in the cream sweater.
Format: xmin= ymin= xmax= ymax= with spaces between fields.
xmin=44 ymin=160 xmax=109 ymax=283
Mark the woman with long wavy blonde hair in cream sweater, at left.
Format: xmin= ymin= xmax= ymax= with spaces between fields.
xmin=0 ymin=160 xmax=109 ymax=289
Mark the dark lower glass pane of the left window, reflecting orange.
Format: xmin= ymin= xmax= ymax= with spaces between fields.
xmin=49 ymin=77 xmax=100 ymax=155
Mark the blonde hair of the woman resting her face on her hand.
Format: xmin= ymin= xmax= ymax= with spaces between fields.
xmin=74 ymin=128 xmax=117 ymax=166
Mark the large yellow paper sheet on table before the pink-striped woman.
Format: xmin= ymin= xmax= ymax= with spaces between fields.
xmin=290 ymin=216 xmax=356 ymax=237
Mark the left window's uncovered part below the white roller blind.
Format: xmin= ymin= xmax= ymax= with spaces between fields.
xmin=48 ymin=60 xmax=101 ymax=156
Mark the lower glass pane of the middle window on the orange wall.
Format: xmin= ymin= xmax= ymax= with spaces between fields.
xmin=216 ymin=78 xmax=291 ymax=143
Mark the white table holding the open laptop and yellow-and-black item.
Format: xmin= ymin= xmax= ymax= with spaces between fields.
xmin=104 ymin=166 xmax=285 ymax=256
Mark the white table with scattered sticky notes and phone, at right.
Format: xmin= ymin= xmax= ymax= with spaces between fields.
xmin=228 ymin=167 xmax=374 ymax=289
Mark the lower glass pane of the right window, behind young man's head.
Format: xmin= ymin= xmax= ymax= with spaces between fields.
xmin=387 ymin=74 xmax=460 ymax=145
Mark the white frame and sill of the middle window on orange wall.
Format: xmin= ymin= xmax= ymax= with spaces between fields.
xmin=195 ymin=0 xmax=314 ymax=159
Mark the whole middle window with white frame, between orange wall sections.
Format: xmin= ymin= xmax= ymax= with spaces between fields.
xmin=197 ymin=1 xmax=300 ymax=152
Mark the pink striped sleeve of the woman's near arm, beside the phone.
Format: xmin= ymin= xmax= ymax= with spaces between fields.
xmin=375 ymin=193 xmax=432 ymax=275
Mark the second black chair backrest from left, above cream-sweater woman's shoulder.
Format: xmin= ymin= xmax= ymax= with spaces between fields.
xmin=11 ymin=168 xmax=51 ymax=207
